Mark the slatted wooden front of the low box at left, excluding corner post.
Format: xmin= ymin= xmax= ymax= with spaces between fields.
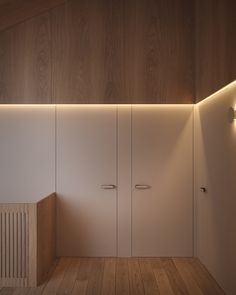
xmin=0 ymin=204 xmax=28 ymax=286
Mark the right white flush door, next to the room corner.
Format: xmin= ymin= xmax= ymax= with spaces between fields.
xmin=132 ymin=106 xmax=193 ymax=256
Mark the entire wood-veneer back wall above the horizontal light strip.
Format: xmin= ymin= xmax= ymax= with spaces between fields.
xmin=0 ymin=0 xmax=194 ymax=103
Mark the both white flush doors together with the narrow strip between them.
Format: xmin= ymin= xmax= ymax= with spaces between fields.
xmin=56 ymin=105 xmax=193 ymax=256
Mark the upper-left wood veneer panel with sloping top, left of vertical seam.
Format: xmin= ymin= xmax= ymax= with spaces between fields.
xmin=0 ymin=13 xmax=51 ymax=103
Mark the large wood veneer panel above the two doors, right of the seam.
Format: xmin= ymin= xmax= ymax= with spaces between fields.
xmin=52 ymin=0 xmax=194 ymax=103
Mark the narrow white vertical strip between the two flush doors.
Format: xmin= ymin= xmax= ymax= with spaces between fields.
xmin=118 ymin=105 xmax=131 ymax=257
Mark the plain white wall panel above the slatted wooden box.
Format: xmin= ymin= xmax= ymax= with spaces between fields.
xmin=0 ymin=105 xmax=55 ymax=203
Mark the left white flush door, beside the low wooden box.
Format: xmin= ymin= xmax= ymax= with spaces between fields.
xmin=56 ymin=105 xmax=117 ymax=256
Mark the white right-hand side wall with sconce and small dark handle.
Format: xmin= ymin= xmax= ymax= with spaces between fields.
xmin=195 ymin=83 xmax=236 ymax=295
